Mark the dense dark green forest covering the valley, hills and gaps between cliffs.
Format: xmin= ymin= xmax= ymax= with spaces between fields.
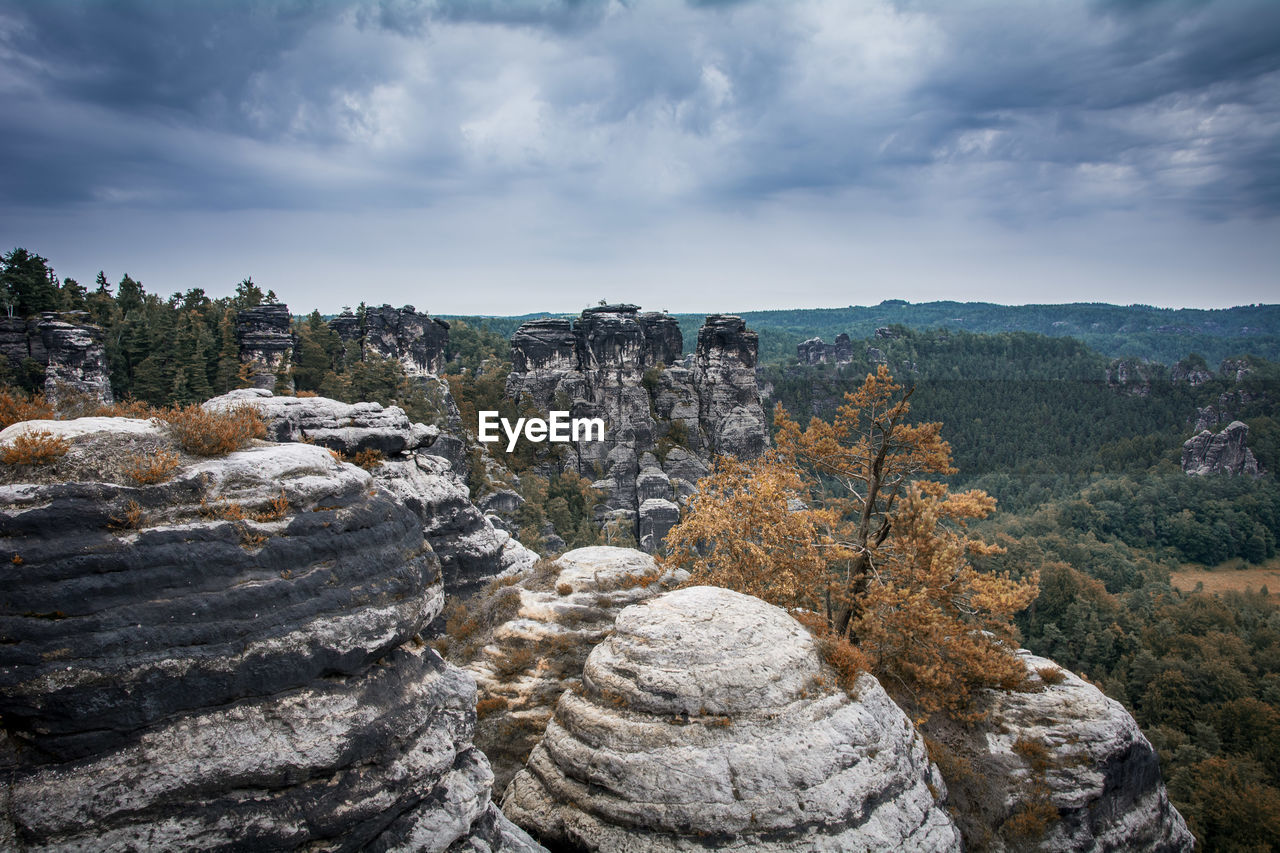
xmin=10 ymin=244 xmax=1280 ymax=849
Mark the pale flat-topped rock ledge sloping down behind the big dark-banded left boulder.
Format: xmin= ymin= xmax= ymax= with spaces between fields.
xmin=205 ymin=388 xmax=538 ymax=596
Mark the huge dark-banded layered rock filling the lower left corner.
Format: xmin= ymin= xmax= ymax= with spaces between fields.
xmin=0 ymin=418 xmax=535 ymax=850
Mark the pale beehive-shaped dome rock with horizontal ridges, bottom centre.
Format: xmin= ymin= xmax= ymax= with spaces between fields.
xmin=503 ymin=587 xmax=960 ymax=850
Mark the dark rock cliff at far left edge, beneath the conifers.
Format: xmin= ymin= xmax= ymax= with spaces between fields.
xmin=0 ymin=311 xmax=113 ymax=402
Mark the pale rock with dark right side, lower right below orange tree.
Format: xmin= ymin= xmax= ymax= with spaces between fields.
xmin=925 ymin=651 xmax=1194 ymax=853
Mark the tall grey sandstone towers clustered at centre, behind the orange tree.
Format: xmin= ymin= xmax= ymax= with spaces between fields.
xmin=507 ymin=305 xmax=768 ymax=551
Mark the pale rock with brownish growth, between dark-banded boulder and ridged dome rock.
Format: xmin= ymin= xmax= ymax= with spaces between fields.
xmin=442 ymin=546 xmax=689 ymax=793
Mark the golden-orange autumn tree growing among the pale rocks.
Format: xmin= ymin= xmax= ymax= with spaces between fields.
xmin=667 ymin=366 xmax=1037 ymax=712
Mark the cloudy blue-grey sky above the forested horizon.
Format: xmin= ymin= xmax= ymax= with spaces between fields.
xmin=0 ymin=0 xmax=1280 ymax=315
